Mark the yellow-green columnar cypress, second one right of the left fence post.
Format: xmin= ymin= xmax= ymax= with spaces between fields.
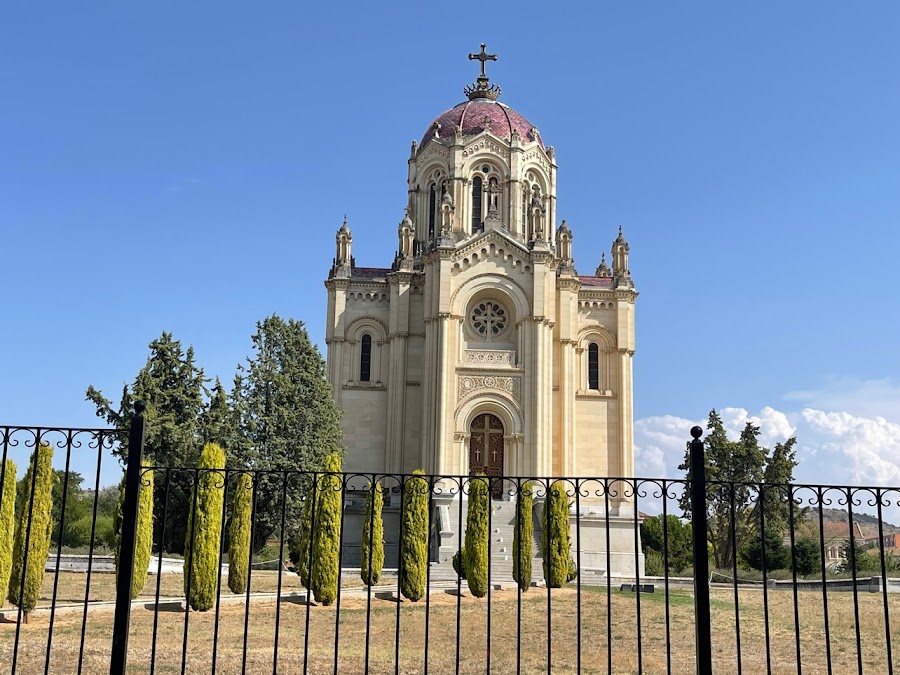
xmin=184 ymin=443 xmax=225 ymax=612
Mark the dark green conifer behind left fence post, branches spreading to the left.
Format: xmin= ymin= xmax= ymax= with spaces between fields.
xmin=86 ymin=332 xmax=204 ymax=553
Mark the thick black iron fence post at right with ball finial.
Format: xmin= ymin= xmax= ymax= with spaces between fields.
xmin=691 ymin=427 xmax=712 ymax=675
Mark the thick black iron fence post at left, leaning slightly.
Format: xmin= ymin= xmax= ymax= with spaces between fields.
xmin=109 ymin=401 xmax=146 ymax=675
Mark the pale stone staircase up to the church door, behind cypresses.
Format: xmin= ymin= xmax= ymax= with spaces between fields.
xmin=431 ymin=500 xmax=542 ymax=583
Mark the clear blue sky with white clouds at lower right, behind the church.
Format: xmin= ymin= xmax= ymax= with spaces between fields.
xmin=0 ymin=1 xmax=900 ymax=492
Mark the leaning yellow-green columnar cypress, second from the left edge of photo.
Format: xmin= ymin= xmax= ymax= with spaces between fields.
xmin=7 ymin=442 xmax=56 ymax=621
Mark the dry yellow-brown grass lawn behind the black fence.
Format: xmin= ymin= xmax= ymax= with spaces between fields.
xmin=0 ymin=572 xmax=900 ymax=675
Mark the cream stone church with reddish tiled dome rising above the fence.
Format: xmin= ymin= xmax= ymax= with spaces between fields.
xmin=325 ymin=45 xmax=638 ymax=576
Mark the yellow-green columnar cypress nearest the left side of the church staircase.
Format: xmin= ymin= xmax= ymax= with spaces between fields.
xmin=400 ymin=469 xmax=429 ymax=602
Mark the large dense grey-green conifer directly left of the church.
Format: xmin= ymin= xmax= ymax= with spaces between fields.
xmin=232 ymin=315 xmax=343 ymax=549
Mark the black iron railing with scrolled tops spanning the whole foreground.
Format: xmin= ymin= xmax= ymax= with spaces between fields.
xmin=0 ymin=420 xmax=900 ymax=674
